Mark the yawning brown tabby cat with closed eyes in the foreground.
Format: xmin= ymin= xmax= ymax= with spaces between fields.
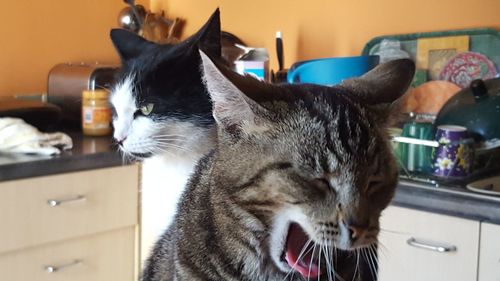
xmin=142 ymin=50 xmax=414 ymax=281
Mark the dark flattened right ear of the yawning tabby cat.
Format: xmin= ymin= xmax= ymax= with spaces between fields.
xmin=341 ymin=59 xmax=415 ymax=123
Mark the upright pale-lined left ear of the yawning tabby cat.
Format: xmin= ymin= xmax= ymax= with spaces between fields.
xmin=200 ymin=50 xmax=265 ymax=134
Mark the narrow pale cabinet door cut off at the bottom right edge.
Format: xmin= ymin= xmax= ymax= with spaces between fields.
xmin=479 ymin=223 xmax=500 ymax=281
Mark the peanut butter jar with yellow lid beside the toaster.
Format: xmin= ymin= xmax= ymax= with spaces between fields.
xmin=82 ymin=90 xmax=111 ymax=136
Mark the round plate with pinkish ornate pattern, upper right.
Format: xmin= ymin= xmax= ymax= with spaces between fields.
xmin=439 ymin=52 xmax=497 ymax=88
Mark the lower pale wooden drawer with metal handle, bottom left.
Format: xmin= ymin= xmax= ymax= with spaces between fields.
xmin=0 ymin=227 xmax=137 ymax=281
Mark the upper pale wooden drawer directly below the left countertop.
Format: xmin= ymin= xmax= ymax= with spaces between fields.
xmin=0 ymin=165 xmax=138 ymax=253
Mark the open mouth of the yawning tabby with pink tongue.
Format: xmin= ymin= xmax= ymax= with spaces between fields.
xmin=282 ymin=223 xmax=326 ymax=278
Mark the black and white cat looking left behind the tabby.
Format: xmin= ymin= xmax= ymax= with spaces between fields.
xmin=111 ymin=9 xmax=221 ymax=244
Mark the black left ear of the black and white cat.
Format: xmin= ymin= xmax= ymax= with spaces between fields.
xmin=110 ymin=29 xmax=154 ymax=62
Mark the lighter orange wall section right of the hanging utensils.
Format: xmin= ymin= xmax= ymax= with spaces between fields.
xmin=150 ymin=0 xmax=500 ymax=71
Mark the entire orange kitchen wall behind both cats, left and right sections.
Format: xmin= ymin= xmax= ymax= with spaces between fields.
xmin=0 ymin=0 xmax=500 ymax=96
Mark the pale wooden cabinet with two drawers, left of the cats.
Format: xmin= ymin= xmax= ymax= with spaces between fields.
xmin=0 ymin=165 xmax=139 ymax=281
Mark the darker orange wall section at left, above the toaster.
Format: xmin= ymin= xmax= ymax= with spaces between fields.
xmin=0 ymin=0 xmax=149 ymax=96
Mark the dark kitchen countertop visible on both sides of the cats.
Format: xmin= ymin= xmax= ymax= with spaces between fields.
xmin=0 ymin=133 xmax=500 ymax=224
